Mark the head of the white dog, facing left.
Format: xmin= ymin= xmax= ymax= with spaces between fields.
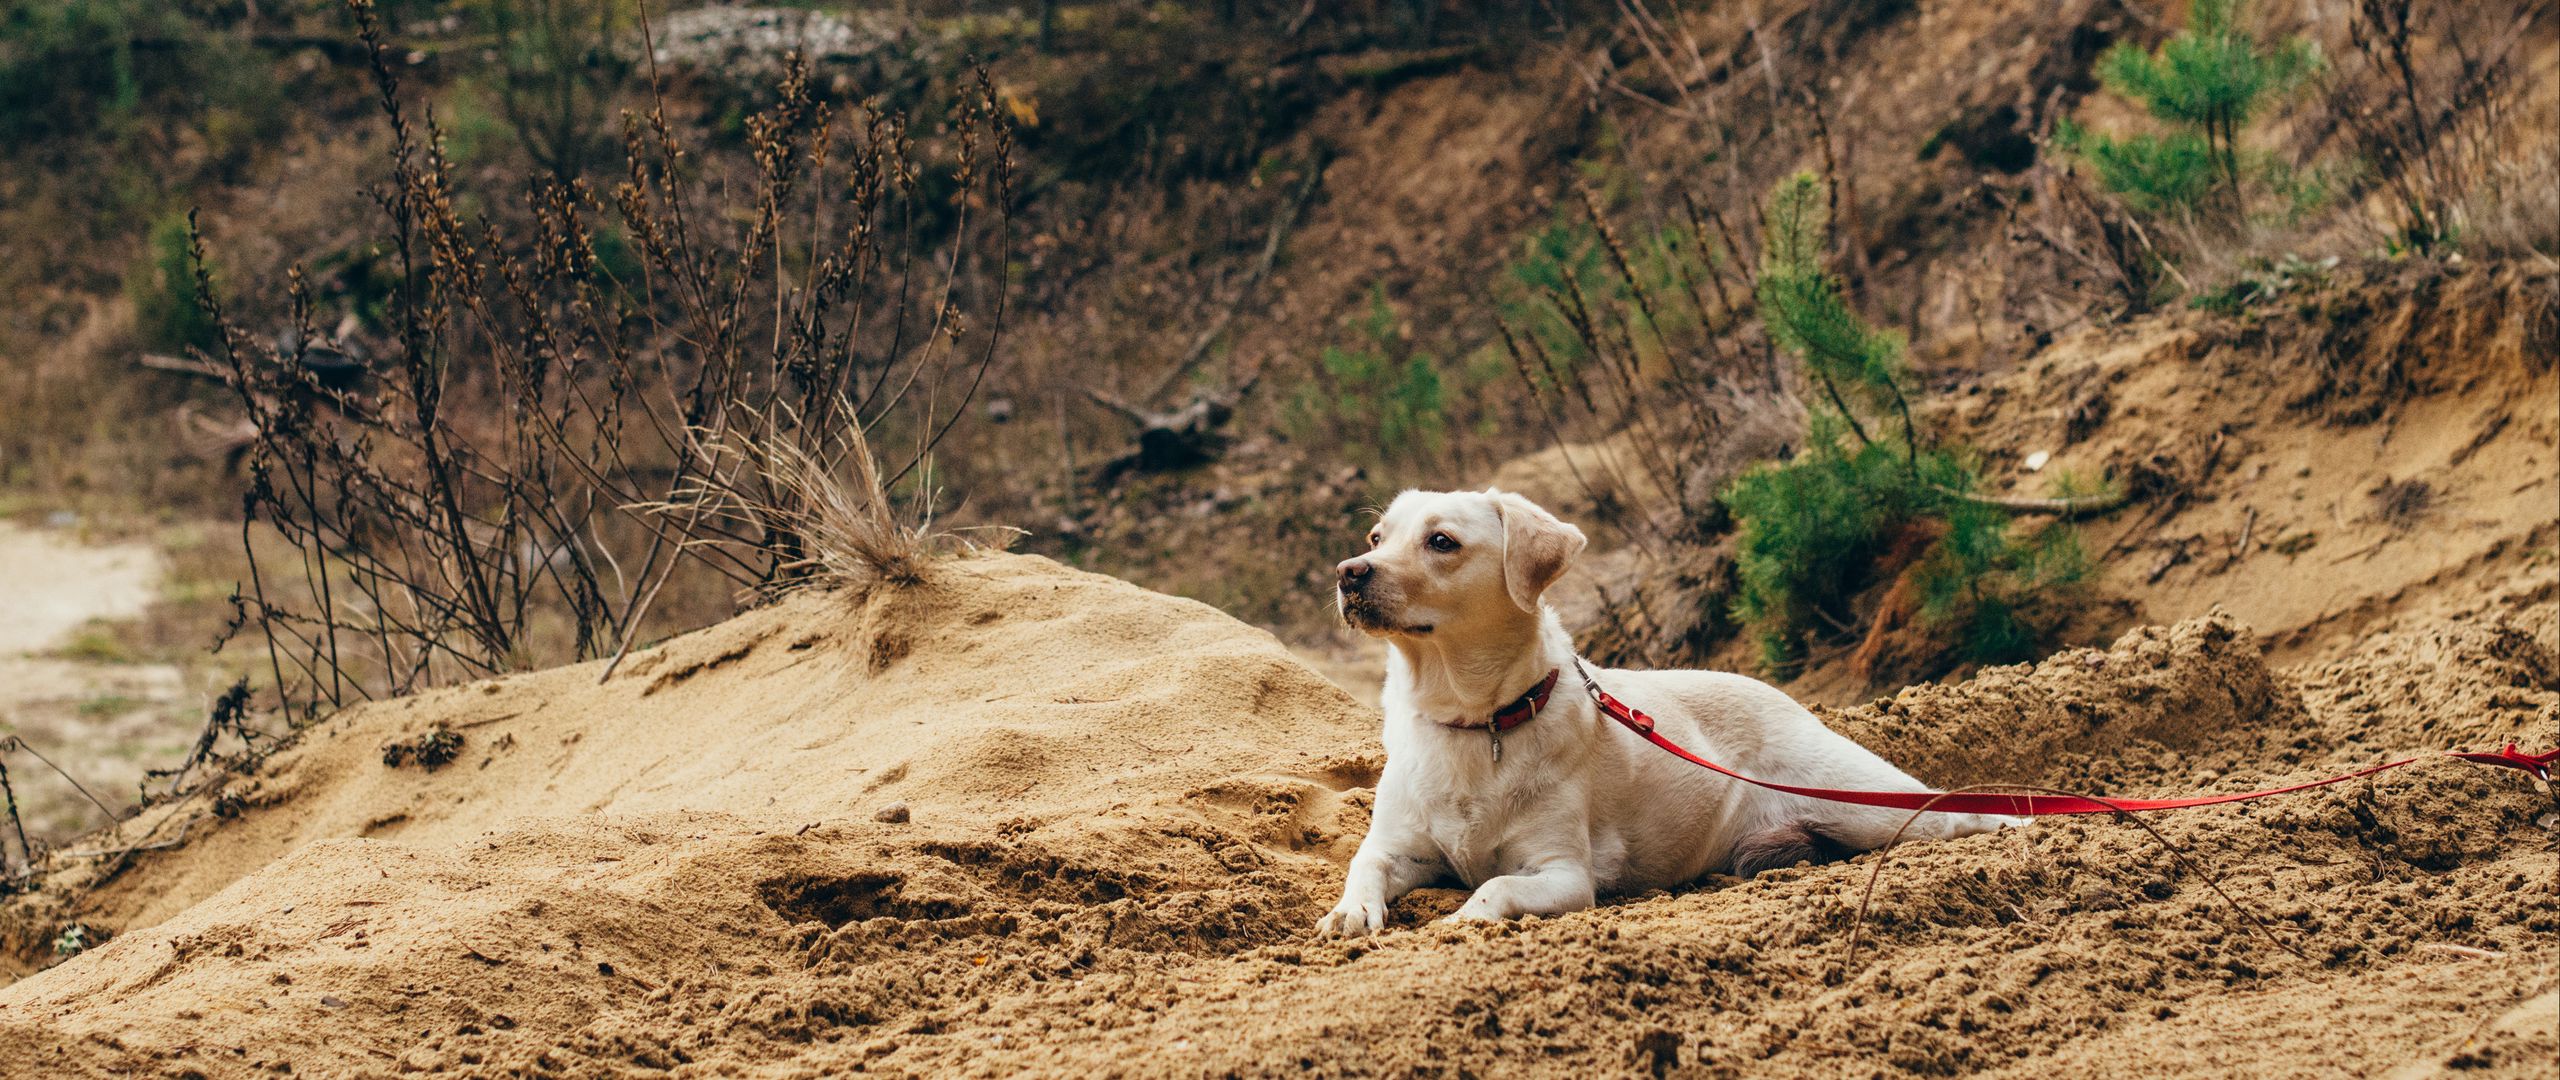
xmin=1334 ymin=489 xmax=1585 ymax=637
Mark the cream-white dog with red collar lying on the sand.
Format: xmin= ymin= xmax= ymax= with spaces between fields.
xmin=1316 ymin=489 xmax=2015 ymax=934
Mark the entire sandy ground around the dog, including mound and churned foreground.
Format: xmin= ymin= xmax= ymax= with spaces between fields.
xmin=0 ymin=558 xmax=2560 ymax=1075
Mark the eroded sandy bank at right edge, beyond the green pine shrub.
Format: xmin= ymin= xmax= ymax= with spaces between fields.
xmin=1956 ymin=264 xmax=2560 ymax=658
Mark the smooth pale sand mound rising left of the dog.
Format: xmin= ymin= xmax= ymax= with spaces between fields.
xmin=0 ymin=558 xmax=1375 ymax=946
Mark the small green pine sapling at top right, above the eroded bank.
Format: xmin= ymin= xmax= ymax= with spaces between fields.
xmin=2053 ymin=0 xmax=2319 ymax=212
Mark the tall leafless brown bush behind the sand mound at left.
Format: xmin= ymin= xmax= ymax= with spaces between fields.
xmin=195 ymin=0 xmax=1014 ymax=714
